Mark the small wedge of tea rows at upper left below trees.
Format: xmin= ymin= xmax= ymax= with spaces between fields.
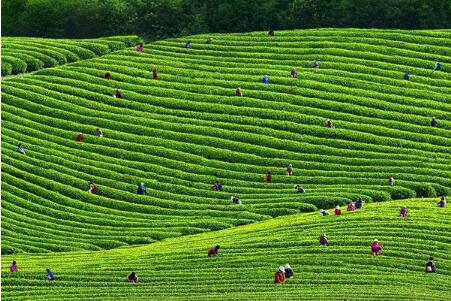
xmin=1 ymin=36 xmax=138 ymax=76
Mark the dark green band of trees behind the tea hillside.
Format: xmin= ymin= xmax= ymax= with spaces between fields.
xmin=2 ymin=0 xmax=451 ymax=40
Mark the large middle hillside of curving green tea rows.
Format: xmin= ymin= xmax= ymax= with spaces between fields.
xmin=2 ymin=30 xmax=451 ymax=253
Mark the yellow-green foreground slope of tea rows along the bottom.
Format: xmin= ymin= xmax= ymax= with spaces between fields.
xmin=2 ymin=199 xmax=451 ymax=300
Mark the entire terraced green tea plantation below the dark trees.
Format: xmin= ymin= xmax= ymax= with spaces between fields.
xmin=1 ymin=29 xmax=451 ymax=300
